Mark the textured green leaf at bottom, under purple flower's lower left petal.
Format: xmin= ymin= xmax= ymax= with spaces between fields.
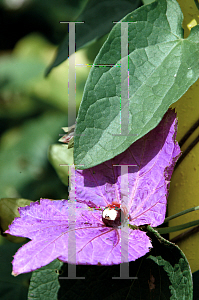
xmin=28 ymin=259 xmax=63 ymax=300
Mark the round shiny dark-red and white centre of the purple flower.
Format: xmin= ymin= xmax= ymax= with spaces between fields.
xmin=102 ymin=204 xmax=121 ymax=227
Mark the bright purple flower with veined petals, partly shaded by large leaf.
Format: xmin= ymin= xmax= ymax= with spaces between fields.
xmin=6 ymin=110 xmax=180 ymax=275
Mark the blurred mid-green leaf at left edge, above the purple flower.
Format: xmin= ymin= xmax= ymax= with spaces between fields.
xmin=0 ymin=113 xmax=67 ymax=200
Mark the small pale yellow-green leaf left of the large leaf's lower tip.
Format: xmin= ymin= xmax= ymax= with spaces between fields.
xmin=48 ymin=144 xmax=73 ymax=186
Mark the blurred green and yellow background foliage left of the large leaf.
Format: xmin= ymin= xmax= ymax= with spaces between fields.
xmin=0 ymin=0 xmax=105 ymax=201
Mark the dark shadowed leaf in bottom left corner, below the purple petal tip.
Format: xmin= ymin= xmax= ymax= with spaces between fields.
xmin=0 ymin=241 xmax=31 ymax=300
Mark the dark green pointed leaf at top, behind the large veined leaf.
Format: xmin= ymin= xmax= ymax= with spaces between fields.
xmin=46 ymin=0 xmax=140 ymax=75
